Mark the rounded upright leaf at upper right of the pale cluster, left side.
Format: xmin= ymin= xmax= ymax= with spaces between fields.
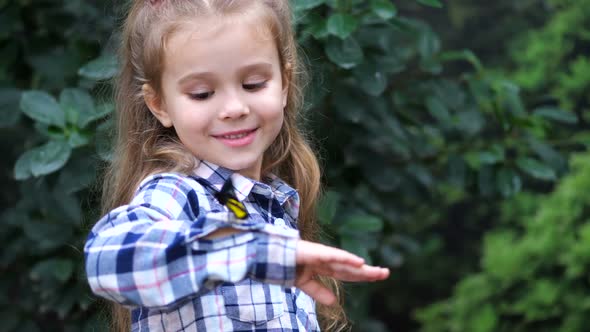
xmin=59 ymin=88 xmax=96 ymax=128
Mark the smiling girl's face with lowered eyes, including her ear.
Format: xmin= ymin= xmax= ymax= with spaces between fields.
xmin=144 ymin=19 xmax=287 ymax=179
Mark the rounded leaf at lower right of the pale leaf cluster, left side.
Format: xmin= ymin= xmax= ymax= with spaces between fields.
xmin=30 ymin=141 xmax=72 ymax=177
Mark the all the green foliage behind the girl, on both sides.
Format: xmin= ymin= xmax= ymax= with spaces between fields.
xmin=0 ymin=0 xmax=590 ymax=331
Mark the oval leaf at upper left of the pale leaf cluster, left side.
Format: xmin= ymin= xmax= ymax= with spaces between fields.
xmin=20 ymin=90 xmax=66 ymax=128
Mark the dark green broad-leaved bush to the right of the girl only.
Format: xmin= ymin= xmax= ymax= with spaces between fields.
xmin=298 ymin=1 xmax=577 ymax=331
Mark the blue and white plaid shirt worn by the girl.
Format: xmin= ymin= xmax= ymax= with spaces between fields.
xmin=84 ymin=162 xmax=319 ymax=332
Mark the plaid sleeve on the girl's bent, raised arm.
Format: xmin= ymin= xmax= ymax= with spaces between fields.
xmin=84 ymin=174 xmax=299 ymax=308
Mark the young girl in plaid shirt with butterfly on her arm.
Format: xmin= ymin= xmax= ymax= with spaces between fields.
xmin=85 ymin=0 xmax=389 ymax=331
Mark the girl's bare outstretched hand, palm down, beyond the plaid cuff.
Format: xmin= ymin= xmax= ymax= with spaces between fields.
xmin=295 ymin=240 xmax=389 ymax=305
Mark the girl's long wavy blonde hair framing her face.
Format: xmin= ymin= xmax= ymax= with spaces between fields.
xmin=102 ymin=0 xmax=349 ymax=332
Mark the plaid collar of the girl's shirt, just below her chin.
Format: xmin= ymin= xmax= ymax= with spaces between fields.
xmin=193 ymin=160 xmax=299 ymax=207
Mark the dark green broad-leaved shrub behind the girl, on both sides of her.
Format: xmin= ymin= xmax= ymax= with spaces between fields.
xmin=0 ymin=0 xmax=577 ymax=331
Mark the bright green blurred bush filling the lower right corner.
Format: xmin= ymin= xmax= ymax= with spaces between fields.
xmin=418 ymin=154 xmax=590 ymax=332
